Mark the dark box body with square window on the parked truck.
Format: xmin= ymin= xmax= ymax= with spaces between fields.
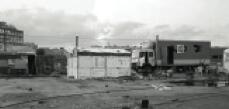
xmin=155 ymin=40 xmax=211 ymax=66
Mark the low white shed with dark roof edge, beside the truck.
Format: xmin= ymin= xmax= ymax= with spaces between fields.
xmin=67 ymin=48 xmax=131 ymax=79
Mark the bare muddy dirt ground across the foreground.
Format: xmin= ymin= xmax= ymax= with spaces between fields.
xmin=0 ymin=77 xmax=229 ymax=109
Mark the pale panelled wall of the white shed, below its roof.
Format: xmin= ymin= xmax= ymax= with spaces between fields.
xmin=68 ymin=56 xmax=131 ymax=79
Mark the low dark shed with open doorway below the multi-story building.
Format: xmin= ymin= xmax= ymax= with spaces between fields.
xmin=0 ymin=46 xmax=36 ymax=76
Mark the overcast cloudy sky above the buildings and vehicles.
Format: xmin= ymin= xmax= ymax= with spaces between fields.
xmin=0 ymin=0 xmax=229 ymax=48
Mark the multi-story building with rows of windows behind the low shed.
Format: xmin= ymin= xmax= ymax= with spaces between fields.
xmin=0 ymin=22 xmax=24 ymax=48
